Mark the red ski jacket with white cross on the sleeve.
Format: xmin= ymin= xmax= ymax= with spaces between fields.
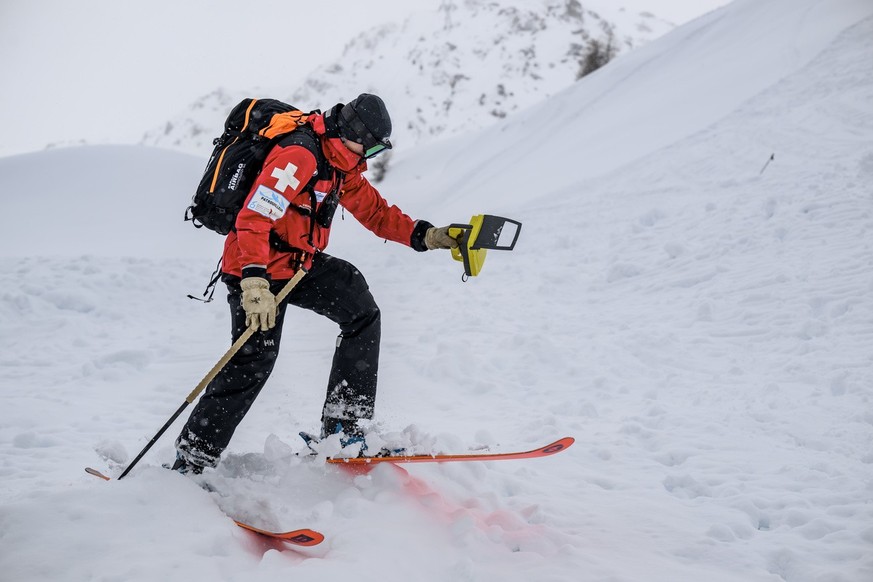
xmin=222 ymin=115 xmax=418 ymax=280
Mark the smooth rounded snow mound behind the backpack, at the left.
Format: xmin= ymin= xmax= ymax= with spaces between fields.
xmin=0 ymin=146 xmax=215 ymax=257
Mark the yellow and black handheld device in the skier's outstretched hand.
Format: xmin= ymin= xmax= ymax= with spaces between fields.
xmin=449 ymin=214 xmax=521 ymax=282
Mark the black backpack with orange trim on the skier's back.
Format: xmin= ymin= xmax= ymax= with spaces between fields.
xmin=185 ymin=99 xmax=320 ymax=235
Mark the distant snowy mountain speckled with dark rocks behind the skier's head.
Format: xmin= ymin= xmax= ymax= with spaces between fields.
xmin=143 ymin=0 xmax=672 ymax=154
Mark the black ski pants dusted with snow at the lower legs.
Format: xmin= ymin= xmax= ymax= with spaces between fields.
xmin=176 ymin=253 xmax=381 ymax=467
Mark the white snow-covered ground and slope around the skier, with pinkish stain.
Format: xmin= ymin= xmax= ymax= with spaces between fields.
xmin=0 ymin=0 xmax=873 ymax=582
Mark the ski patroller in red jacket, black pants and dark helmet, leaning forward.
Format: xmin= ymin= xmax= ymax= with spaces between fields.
xmin=172 ymin=93 xmax=457 ymax=473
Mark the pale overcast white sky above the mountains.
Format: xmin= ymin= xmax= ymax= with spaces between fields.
xmin=0 ymin=0 xmax=728 ymax=156
